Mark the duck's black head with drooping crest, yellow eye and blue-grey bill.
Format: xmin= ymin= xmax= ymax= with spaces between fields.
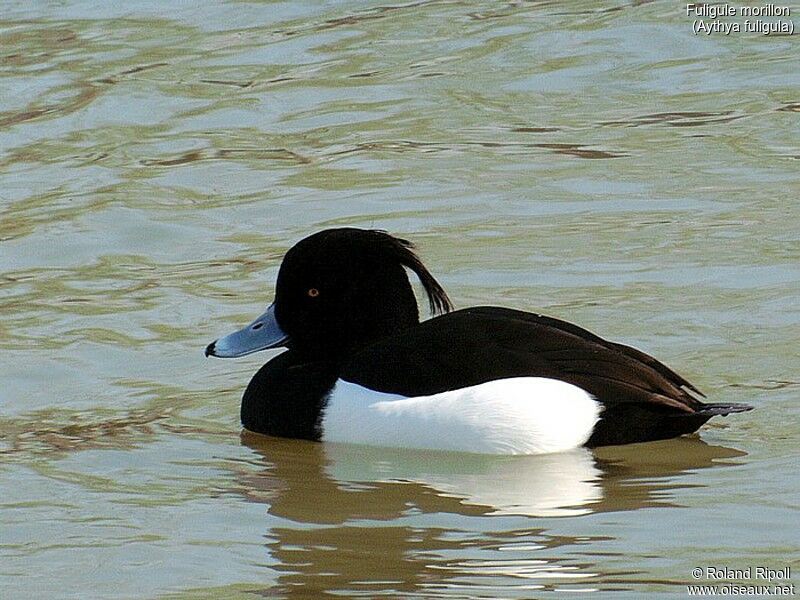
xmin=206 ymin=228 xmax=451 ymax=361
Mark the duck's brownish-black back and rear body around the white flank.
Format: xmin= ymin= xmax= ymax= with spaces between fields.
xmin=340 ymin=307 xmax=709 ymax=445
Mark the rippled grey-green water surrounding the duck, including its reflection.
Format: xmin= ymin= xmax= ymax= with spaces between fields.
xmin=0 ymin=0 xmax=800 ymax=599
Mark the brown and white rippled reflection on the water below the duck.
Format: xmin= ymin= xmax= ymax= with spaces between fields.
xmin=237 ymin=432 xmax=745 ymax=597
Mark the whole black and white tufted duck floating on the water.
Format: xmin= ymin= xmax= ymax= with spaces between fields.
xmin=205 ymin=228 xmax=752 ymax=454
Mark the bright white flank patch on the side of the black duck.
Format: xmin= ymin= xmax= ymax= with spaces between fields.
xmin=322 ymin=377 xmax=601 ymax=454
